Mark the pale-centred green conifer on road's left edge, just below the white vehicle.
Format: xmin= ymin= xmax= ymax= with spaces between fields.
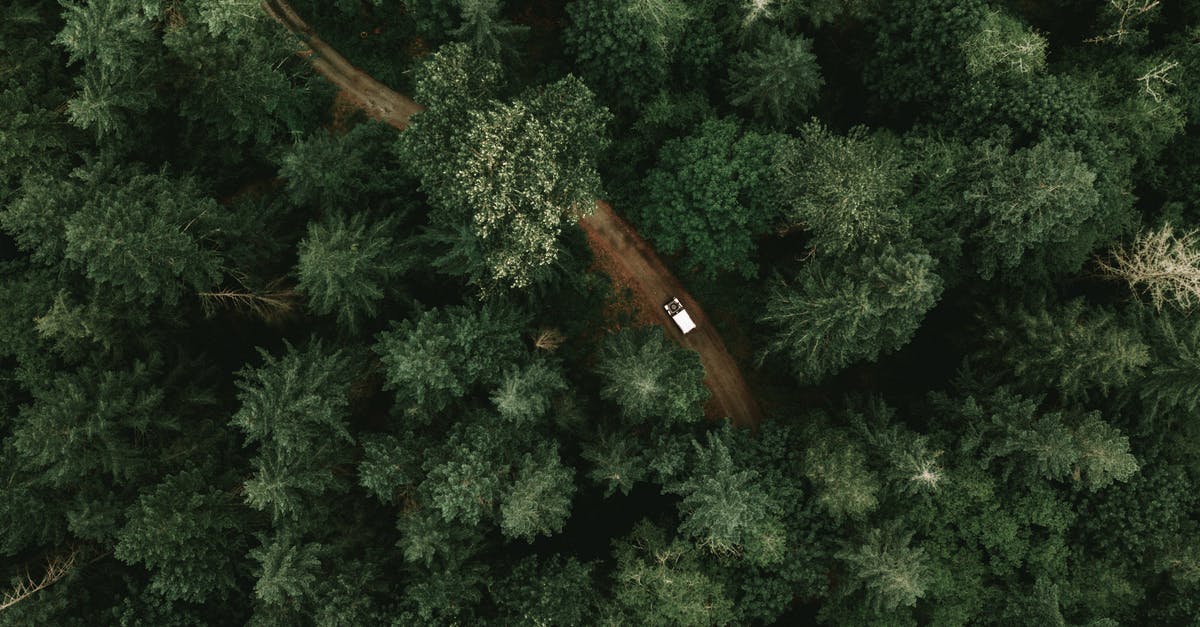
xmin=596 ymin=327 xmax=708 ymax=424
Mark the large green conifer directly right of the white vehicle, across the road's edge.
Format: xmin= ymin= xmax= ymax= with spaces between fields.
xmin=762 ymin=245 xmax=942 ymax=382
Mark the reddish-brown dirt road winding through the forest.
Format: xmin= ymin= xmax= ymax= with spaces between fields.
xmin=263 ymin=0 xmax=762 ymax=426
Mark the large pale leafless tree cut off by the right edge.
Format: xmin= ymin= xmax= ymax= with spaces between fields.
xmin=1099 ymin=225 xmax=1200 ymax=310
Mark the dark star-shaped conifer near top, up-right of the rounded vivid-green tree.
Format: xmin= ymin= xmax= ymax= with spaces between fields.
xmin=727 ymin=31 xmax=824 ymax=129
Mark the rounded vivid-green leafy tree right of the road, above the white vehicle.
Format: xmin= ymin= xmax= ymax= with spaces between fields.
xmin=641 ymin=119 xmax=780 ymax=279
